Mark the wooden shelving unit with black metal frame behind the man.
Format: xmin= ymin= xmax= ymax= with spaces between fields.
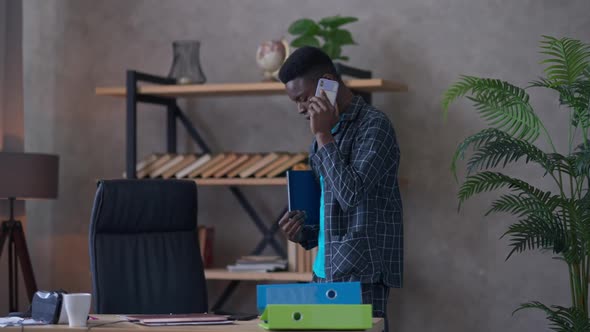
xmin=96 ymin=65 xmax=408 ymax=310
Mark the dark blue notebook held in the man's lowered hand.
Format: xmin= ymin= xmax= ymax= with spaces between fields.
xmin=287 ymin=171 xmax=322 ymax=225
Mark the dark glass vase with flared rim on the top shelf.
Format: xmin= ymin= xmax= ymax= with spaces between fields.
xmin=168 ymin=40 xmax=207 ymax=84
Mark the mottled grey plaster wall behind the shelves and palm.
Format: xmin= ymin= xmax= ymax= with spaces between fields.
xmin=19 ymin=0 xmax=590 ymax=331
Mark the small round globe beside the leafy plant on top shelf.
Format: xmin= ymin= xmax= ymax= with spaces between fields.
xmin=256 ymin=40 xmax=289 ymax=81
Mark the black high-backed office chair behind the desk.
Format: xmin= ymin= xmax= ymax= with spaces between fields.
xmin=90 ymin=180 xmax=207 ymax=314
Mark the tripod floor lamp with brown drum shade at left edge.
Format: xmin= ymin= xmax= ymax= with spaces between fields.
xmin=0 ymin=152 xmax=59 ymax=311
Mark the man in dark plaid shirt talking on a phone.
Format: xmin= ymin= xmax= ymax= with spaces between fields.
xmin=279 ymin=47 xmax=403 ymax=331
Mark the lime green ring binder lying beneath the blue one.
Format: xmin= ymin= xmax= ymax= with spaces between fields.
xmin=259 ymin=304 xmax=373 ymax=330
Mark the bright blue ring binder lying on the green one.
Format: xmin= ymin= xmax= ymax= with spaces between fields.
xmin=256 ymin=281 xmax=362 ymax=313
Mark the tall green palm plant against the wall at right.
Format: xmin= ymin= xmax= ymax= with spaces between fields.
xmin=442 ymin=36 xmax=590 ymax=331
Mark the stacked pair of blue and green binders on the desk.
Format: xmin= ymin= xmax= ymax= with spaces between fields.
xmin=256 ymin=282 xmax=373 ymax=330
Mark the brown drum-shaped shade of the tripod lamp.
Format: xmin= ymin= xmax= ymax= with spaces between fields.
xmin=0 ymin=152 xmax=59 ymax=199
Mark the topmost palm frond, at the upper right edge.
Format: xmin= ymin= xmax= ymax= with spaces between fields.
xmin=541 ymin=36 xmax=590 ymax=85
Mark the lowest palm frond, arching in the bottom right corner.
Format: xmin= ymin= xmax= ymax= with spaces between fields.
xmin=512 ymin=301 xmax=590 ymax=332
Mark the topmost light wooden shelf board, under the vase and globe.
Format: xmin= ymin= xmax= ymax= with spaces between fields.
xmin=96 ymin=78 xmax=408 ymax=97
